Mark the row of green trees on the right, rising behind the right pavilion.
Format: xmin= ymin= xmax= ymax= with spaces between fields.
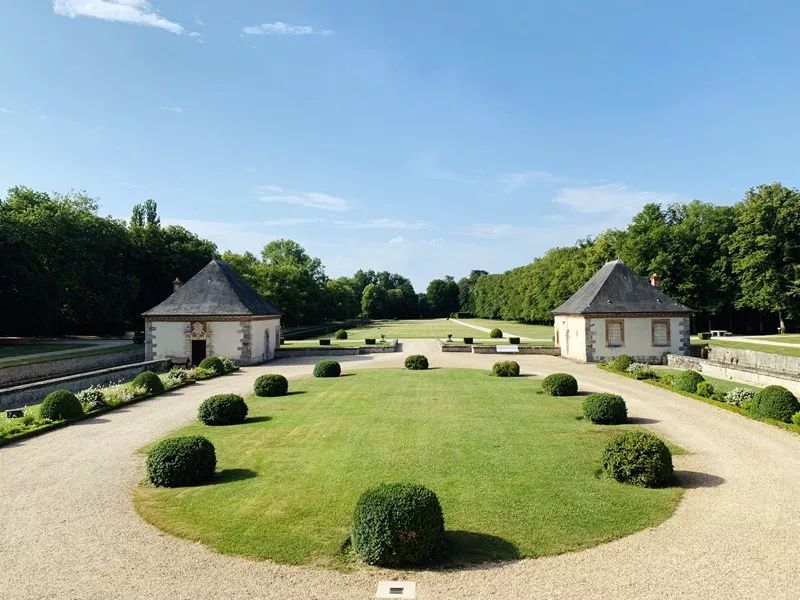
xmin=470 ymin=183 xmax=800 ymax=333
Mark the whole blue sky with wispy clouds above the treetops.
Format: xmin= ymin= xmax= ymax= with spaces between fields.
xmin=0 ymin=0 xmax=800 ymax=288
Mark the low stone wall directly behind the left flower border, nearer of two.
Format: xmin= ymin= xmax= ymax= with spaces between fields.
xmin=0 ymin=360 xmax=172 ymax=410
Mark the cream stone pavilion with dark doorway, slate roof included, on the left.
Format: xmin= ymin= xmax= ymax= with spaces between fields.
xmin=142 ymin=260 xmax=281 ymax=365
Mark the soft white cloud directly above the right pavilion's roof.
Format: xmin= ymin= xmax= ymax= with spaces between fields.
xmin=553 ymin=183 xmax=684 ymax=215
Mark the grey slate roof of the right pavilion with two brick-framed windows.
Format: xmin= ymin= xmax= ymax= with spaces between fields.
xmin=553 ymin=260 xmax=694 ymax=315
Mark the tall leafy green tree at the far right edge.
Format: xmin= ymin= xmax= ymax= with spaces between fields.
xmin=728 ymin=183 xmax=800 ymax=331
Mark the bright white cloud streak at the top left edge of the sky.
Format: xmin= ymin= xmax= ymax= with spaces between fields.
xmin=53 ymin=0 xmax=184 ymax=35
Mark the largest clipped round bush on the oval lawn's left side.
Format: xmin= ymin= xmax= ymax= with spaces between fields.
xmin=147 ymin=435 xmax=217 ymax=487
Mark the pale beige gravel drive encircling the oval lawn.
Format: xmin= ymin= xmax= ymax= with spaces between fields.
xmin=0 ymin=341 xmax=800 ymax=600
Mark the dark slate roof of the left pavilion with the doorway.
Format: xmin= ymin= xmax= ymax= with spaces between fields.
xmin=142 ymin=260 xmax=281 ymax=317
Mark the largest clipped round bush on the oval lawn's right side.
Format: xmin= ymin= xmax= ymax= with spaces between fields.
xmin=603 ymin=431 xmax=673 ymax=487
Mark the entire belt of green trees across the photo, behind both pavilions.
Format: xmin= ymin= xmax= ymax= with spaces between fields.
xmin=0 ymin=183 xmax=800 ymax=335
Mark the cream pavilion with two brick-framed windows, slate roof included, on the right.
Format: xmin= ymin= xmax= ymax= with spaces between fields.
xmin=553 ymin=260 xmax=692 ymax=364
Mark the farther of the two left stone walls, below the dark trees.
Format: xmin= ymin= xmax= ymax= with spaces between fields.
xmin=0 ymin=345 xmax=144 ymax=387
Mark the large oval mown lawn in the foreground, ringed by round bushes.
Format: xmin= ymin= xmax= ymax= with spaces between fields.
xmin=135 ymin=369 xmax=682 ymax=568
